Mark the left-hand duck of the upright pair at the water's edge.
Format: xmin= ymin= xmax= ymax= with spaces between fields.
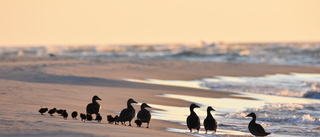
xmin=187 ymin=103 xmax=200 ymax=133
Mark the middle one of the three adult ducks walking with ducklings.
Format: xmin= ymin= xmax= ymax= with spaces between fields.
xmin=117 ymin=98 xmax=138 ymax=126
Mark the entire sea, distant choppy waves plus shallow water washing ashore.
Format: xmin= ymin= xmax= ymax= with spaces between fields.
xmin=0 ymin=42 xmax=320 ymax=137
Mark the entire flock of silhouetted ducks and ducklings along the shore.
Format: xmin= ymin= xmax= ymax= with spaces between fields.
xmin=39 ymin=96 xmax=270 ymax=136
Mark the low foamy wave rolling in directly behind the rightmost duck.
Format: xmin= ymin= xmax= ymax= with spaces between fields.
xmin=222 ymin=103 xmax=320 ymax=125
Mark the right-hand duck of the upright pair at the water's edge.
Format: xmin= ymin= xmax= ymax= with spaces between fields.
xmin=203 ymin=106 xmax=218 ymax=134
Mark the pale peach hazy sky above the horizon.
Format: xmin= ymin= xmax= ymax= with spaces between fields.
xmin=0 ymin=0 xmax=320 ymax=46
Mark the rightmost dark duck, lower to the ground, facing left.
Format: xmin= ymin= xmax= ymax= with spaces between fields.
xmin=247 ymin=112 xmax=270 ymax=136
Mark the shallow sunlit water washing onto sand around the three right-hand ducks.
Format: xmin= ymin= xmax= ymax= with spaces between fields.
xmin=126 ymin=73 xmax=320 ymax=136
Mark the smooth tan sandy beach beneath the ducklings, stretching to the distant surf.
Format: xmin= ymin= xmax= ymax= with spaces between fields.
xmin=0 ymin=56 xmax=320 ymax=137
